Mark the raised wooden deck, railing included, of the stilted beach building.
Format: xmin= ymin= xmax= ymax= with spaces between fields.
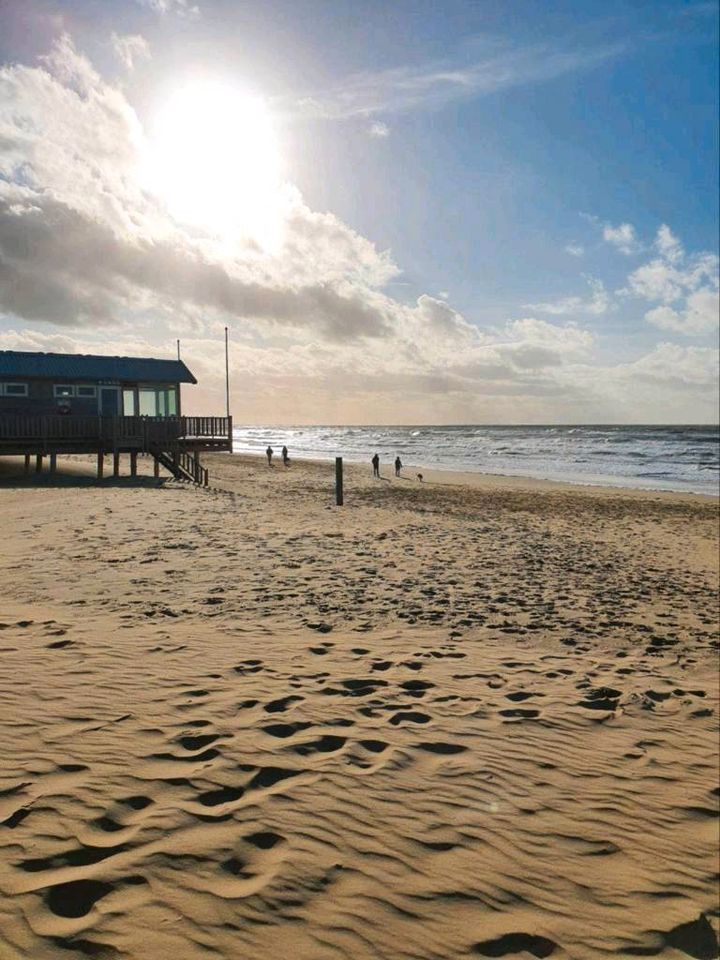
xmin=0 ymin=415 xmax=232 ymax=456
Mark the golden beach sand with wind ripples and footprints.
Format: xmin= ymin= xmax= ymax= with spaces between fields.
xmin=0 ymin=455 xmax=719 ymax=960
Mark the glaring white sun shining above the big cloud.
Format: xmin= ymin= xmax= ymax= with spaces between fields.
xmin=144 ymin=82 xmax=282 ymax=245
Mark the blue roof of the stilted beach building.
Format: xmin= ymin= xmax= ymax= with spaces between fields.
xmin=0 ymin=350 xmax=197 ymax=383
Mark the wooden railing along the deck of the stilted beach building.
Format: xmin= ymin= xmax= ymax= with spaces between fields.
xmin=0 ymin=414 xmax=232 ymax=450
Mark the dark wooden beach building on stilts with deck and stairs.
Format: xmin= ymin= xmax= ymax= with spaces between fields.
xmin=0 ymin=350 xmax=232 ymax=484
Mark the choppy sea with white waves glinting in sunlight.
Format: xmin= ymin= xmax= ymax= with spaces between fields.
xmin=234 ymin=426 xmax=720 ymax=496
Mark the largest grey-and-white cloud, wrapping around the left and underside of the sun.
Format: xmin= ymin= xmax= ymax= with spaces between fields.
xmin=0 ymin=38 xmax=398 ymax=339
